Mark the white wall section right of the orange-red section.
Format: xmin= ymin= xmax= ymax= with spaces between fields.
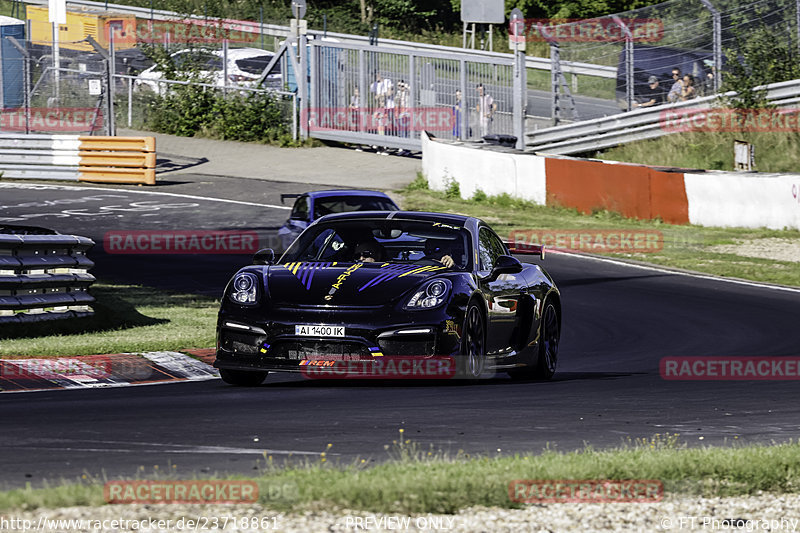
xmin=683 ymin=172 xmax=800 ymax=229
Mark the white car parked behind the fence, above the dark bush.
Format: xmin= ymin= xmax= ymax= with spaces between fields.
xmin=135 ymin=48 xmax=283 ymax=94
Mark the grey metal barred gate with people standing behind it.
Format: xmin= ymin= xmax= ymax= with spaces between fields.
xmin=308 ymin=40 xmax=515 ymax=149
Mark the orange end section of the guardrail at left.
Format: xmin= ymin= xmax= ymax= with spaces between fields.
xmin=78 ymin=136 xmax=156 ymax=185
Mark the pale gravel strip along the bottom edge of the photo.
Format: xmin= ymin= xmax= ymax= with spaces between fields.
xmin=0 ymin=494 xmax=800 ymax=533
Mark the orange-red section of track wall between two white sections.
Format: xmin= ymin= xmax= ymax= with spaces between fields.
xmin=545 ymin=158 xmax=689 ymax=224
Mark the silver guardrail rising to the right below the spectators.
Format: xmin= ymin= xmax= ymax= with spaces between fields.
xmin=525 ymin=80 xmax=800 ymax=155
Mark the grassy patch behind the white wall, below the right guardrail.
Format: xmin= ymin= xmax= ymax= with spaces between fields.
xmin=593 ymin=132 xmax=800 ymax=172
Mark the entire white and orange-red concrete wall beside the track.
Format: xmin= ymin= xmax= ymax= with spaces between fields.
xmin=422 ymin=134 xmax=800 ymax=229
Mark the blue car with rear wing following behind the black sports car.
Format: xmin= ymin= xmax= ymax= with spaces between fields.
xmin=278 ymin=189 xmax=400 ymax=250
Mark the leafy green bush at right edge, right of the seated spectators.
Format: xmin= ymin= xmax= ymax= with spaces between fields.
xmin=723 ymin=25 xmax=800 ymax=109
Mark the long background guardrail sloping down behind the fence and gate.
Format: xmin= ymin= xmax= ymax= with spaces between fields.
xmin=24 ymin=0 xmax=617 ymax=78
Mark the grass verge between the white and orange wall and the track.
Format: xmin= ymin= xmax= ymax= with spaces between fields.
xmin=401 ymin=175 xmax=800 ymax=286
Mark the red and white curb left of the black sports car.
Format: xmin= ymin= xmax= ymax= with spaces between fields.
xmin=0 ymin=349 xmax=219 ymax=392
